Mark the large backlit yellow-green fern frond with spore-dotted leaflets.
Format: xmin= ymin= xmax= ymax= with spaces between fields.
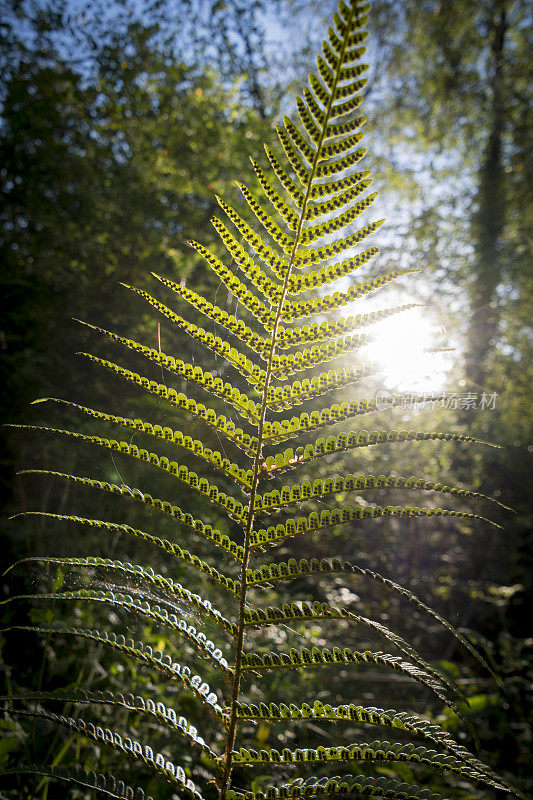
xmin=5 ymin=0 xmax=512 ymax=800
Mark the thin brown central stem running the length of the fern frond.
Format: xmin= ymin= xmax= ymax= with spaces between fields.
xmin=220 ymin=7 xmax=357 ymax=800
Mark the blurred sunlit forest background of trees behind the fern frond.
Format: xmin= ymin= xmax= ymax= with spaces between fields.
xmin=0 ymin=0 xmax=533 ymax=800
